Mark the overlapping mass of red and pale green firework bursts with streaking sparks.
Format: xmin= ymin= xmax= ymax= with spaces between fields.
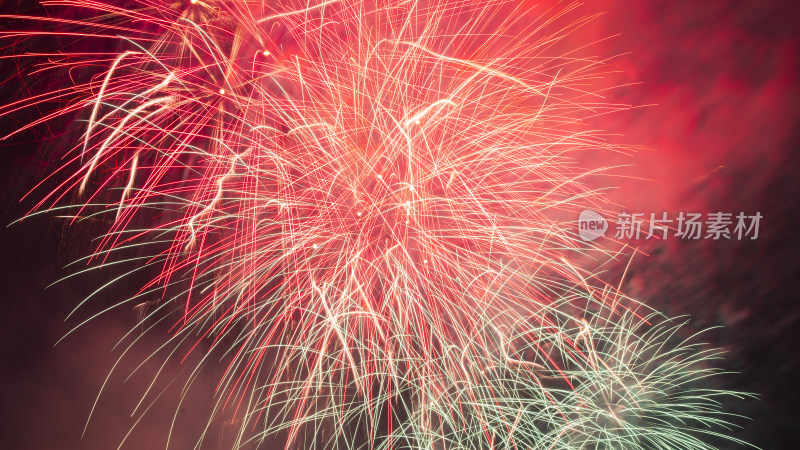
xmin=0 ymin=0 xmax=752 ymax=449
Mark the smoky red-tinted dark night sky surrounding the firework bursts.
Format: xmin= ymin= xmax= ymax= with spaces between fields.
xmin=0 ymin=0 xmax=800 ymax=449
